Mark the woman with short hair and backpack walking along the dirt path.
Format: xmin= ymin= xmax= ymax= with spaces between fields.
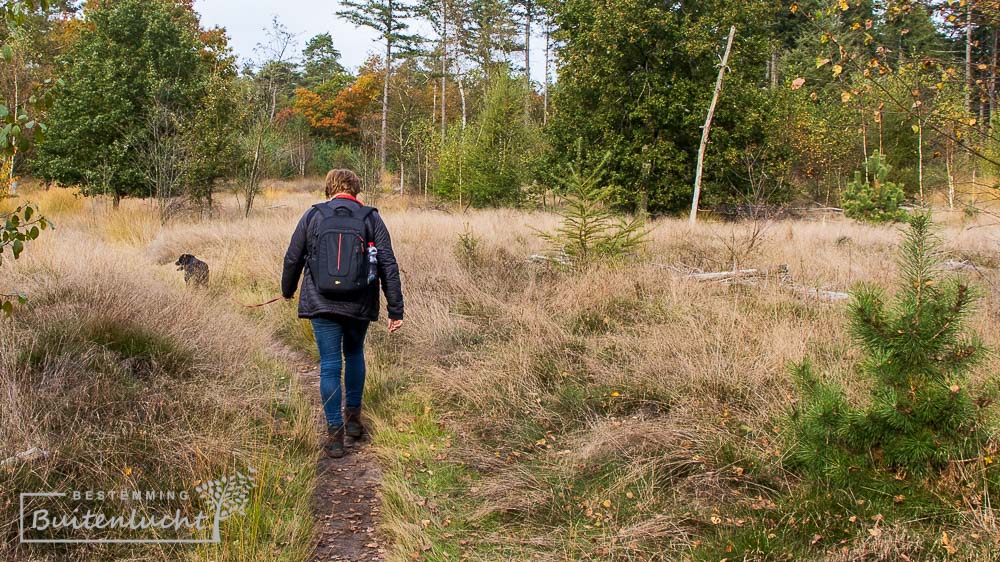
xmin=281 ymin=170 xmax=403 ymax=458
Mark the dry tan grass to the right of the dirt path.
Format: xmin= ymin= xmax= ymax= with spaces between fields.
xmin=360 ymin=199 xmax=1000 ymax=560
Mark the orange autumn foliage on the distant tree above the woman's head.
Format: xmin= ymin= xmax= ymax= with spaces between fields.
xmin=291 ymin=74 xmax=381 ymax=140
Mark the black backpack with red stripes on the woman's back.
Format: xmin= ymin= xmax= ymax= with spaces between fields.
xmin=307 ymin=203 xmax=376 ymax=297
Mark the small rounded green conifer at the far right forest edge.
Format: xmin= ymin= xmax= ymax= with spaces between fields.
xmin=843 ymin=150 xmax=907 ymax=223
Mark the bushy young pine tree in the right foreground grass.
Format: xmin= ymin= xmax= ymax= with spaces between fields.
xmin=790 ymin=214 xmax=986 ymax=481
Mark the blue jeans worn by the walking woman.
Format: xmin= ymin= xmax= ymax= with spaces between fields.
xmin=312 ymin=318 xmax=369 ymax=427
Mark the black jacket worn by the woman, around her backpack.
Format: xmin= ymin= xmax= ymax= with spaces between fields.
xmin=281 ymin=198 xmax=403 ymax=320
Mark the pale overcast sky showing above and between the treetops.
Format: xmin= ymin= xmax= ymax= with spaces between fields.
xmin=188 ymin=0 xmax=545 ymax=82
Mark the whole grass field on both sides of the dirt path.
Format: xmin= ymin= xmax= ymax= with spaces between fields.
xmin=0 ymin=182 xmax=1000 ymax=560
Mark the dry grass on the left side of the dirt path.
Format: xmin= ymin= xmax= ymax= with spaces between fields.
xmin=0 ymin=190 xmax=317 ymax=560
